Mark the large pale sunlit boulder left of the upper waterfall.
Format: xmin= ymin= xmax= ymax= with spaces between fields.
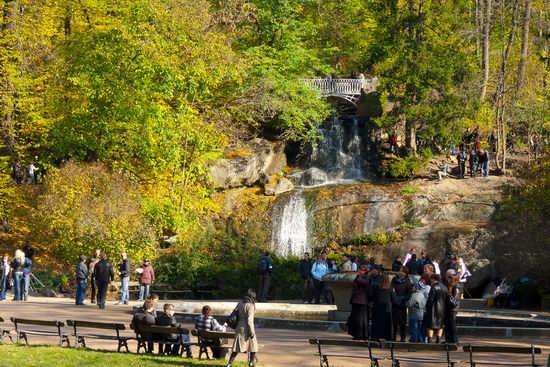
xmin=210 ymin=138 xmax=286 ymax=189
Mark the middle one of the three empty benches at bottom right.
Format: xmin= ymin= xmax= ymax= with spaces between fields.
xmin=384 ymin=341 xmax=460 ymax=367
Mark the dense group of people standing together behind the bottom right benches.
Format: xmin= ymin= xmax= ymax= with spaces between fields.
xmin=348 ymin=249 xmax=471 ymax=343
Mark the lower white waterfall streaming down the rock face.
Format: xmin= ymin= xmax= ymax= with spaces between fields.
xmin=271 ymin=191 xmax=309 ymax=256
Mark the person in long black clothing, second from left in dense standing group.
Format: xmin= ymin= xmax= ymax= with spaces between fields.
xmin=371 ymin=274 xmax=393 ymax=340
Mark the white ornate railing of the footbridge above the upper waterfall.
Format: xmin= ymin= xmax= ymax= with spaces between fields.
xmin=299 ymin=78 xmax=378 ymax=97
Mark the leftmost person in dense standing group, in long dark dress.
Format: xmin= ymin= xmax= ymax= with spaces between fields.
xmin=348 ymin=265 xmax=369 ymax=340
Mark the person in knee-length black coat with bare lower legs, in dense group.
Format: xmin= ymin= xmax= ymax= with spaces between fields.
xmin=425 ymin=274 xmax=447 ymax=343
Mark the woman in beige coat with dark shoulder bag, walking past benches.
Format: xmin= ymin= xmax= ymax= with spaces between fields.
xmin=226 ymin=289 xmax=258 ymax=367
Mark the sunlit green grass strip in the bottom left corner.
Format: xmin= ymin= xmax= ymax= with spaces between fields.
xmin=0 ymin=344 xmax=245 ymax=367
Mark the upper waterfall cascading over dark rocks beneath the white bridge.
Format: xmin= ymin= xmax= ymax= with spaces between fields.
xmin=300 ymin=116 xmax=366 ymax=186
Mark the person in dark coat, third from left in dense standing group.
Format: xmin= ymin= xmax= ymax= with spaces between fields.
xmin=391 ymin=266 xmax=412 ymax=342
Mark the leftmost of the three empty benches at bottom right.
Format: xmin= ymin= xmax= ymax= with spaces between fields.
xmin=309 ymin=338 xmax=386 ymax=367
